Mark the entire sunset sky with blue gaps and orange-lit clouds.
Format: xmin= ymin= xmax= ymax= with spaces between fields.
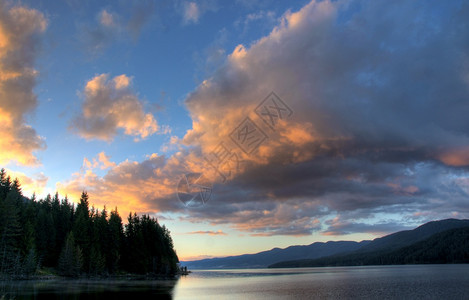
xmin=0 ymin=0 xmax=469 ymax=260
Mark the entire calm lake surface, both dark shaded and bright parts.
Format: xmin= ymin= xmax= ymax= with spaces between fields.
xmin=0 ymin=265 xmax=469 ymax=300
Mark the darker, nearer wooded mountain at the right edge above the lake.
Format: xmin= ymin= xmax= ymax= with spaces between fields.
xmin=269 ymin=219 xmax=469 ymax=268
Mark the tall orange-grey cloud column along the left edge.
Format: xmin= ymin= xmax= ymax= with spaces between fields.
xmin=0 ymin=1 xmax=47 ymax=166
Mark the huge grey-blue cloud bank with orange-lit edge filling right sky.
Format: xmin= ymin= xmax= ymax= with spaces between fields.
xmin=60 ymin=1 xmax=469 ymax=236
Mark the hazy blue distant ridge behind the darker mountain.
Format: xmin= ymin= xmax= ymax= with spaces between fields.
xmin=181 ymin=241 xmax=370 ymax=269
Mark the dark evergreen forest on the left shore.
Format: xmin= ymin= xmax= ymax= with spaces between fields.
xmin=0 ymin=169 xmax=179 ymax=279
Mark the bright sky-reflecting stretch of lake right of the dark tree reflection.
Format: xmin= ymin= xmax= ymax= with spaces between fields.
xmin=174 ymin=265 xmax=469 ymax=300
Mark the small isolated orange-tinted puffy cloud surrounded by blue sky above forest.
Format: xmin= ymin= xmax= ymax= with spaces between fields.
xmin=71 ymin=74 xmax=158 ymax=141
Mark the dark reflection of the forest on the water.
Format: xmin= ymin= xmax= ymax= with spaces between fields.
xmin=0 ymin=280 xmax=177 ymax=299
